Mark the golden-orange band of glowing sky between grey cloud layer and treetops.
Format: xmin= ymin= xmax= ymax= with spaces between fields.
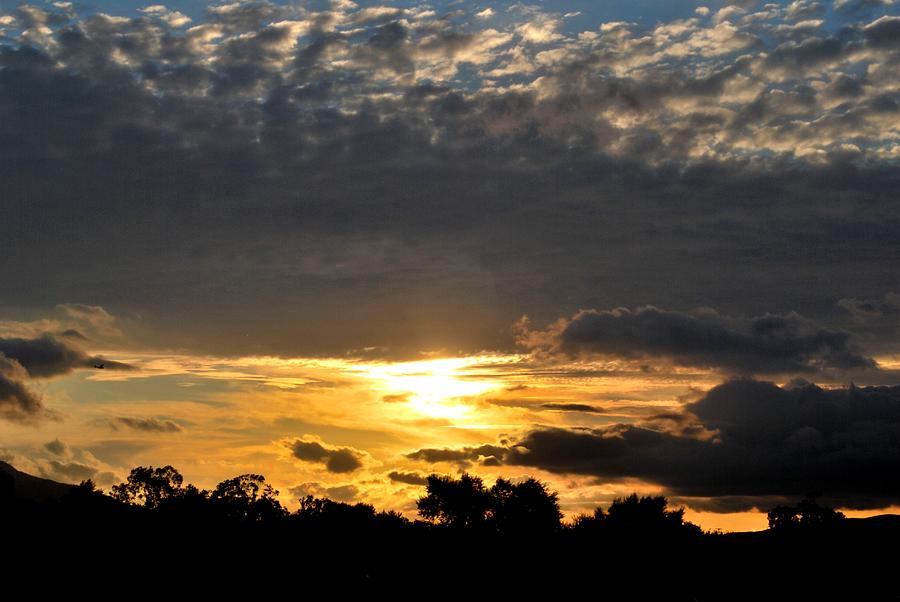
xmin=0 ymin=351 xmax=898 ymax=531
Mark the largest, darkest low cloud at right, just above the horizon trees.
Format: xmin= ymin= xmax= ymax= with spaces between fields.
xmin=409 ymin=380 xmax=900 ymax=510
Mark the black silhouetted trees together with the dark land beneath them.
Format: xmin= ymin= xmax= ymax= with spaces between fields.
xmin=0 ymin=466 xmax=884 ymax=600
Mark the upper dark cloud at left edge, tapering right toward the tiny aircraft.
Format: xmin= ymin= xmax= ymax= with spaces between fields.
xmin=0 ymin=335 xmax=133 ymax=378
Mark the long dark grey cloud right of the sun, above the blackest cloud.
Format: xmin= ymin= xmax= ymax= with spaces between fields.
xmin=524 ymin=307 xmax=875 ymax=374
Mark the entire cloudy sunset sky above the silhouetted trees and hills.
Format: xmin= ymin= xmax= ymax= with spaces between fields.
xmin=0 ymin=0 xmax=900 ymax=530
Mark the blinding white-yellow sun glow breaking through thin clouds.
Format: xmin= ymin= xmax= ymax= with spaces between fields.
xmin=366 ymin=357 xmax=503 ymax=421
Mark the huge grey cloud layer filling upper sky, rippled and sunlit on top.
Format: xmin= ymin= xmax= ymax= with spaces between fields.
xmin=0 ymin=2 xmax=900 ymax=355
